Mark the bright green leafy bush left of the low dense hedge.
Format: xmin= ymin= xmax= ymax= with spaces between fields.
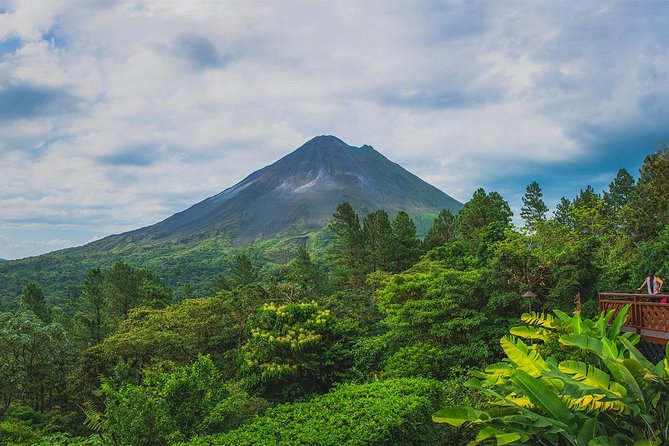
xmin=96 ymin=356 xmax=266 ymax=446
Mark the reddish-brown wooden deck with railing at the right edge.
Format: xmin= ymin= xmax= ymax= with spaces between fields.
xmin=599 ymin=293 xmax=669 ymax=345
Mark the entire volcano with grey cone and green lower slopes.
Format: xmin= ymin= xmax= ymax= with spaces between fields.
xmin=0 ymin=136 xmax=462 ymax=304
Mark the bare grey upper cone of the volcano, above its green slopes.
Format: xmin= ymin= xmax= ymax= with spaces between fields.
xmin=95 ymin=136 xmax=462 ymax=244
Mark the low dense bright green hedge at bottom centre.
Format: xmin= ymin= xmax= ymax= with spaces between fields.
xmin=180 ymin=378 xmax=453 ymax=446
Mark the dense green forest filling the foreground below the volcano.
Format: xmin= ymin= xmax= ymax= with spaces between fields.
xmin=0 ymin=148 xmax=669 ymax=446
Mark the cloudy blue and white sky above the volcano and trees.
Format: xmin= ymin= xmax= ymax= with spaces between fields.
xmin=0 ymin=0 xmax=669 ymax=259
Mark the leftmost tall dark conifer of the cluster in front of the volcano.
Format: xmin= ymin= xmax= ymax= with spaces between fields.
xmin=330 ymin=202 xmax=369 ymax=289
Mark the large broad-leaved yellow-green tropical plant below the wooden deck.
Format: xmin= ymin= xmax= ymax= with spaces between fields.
xmin=434 ymin=306 xmax=669 ymax=446
